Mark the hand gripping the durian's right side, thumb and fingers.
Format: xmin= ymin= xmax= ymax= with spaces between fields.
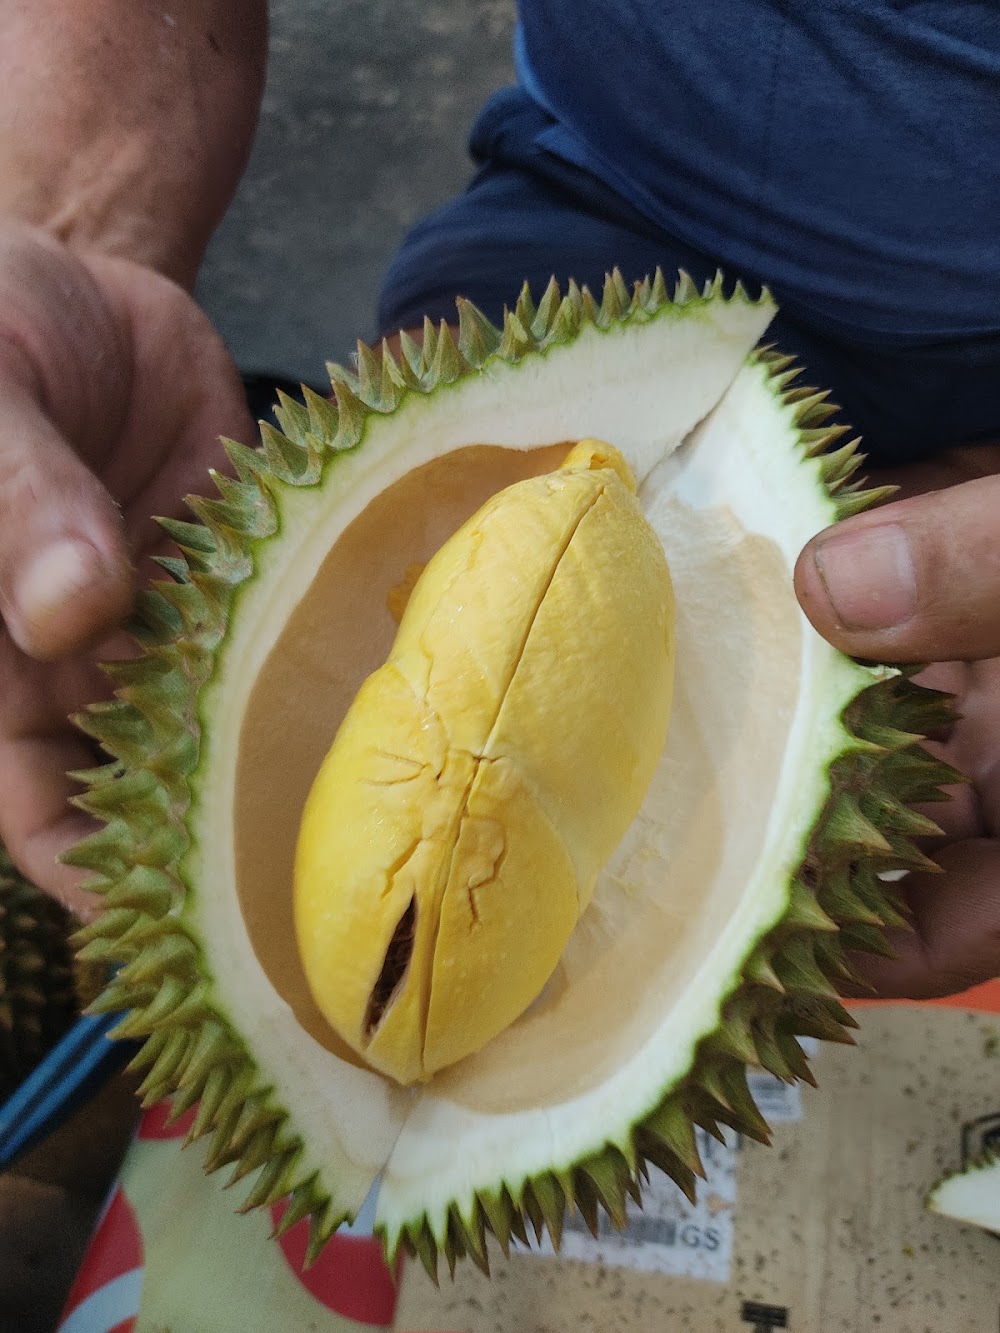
xmin=795 ymin=445 xmax=1000 ymax=998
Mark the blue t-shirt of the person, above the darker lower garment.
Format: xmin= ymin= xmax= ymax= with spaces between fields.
xmin=516 ymin=0 xmax=1000 ymax=344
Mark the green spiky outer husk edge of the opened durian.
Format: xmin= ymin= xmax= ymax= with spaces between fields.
xmin=64 ymin=272 xmax=957 ymax=1274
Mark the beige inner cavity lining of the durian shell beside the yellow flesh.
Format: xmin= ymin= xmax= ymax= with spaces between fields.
xmin=233 ymin=443 xmax=801 ymax=1113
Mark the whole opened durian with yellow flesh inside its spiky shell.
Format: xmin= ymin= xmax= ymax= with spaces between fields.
xmin=72 ymin=267 xmax=952 ymax=1272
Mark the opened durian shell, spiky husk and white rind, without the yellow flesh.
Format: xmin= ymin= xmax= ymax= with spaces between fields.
xmin=72 ymin=273 xmax=953 ymax=1272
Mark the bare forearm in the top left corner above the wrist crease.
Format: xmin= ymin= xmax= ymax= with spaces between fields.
xmin=0 ymin=0 xmax=267 ymax=285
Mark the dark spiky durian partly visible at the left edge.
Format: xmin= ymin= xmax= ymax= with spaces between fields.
xmin=0 ymin=844 xmax=100 ymax=1101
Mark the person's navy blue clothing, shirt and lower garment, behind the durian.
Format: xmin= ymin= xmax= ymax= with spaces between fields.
xmin=380 ymin=0 xmax=1000 ymax=464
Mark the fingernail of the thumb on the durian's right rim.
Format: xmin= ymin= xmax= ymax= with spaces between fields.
xmin=813 ymin=523 xmax=916 ymax=629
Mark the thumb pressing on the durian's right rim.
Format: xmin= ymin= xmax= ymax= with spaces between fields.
xmin=795 ymin=476 xmax=1000 ymax=663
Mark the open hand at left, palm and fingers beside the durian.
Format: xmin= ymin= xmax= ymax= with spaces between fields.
xmin=0 ymin=224 xmax=252 ymax=916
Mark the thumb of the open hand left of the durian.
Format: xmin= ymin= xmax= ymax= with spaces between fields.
xmin=0 ymin=228 xmax=132 ymax=659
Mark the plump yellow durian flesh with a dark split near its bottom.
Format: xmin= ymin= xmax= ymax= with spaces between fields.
xmin=295 ymin=441 xmax=673 ymax=1084
